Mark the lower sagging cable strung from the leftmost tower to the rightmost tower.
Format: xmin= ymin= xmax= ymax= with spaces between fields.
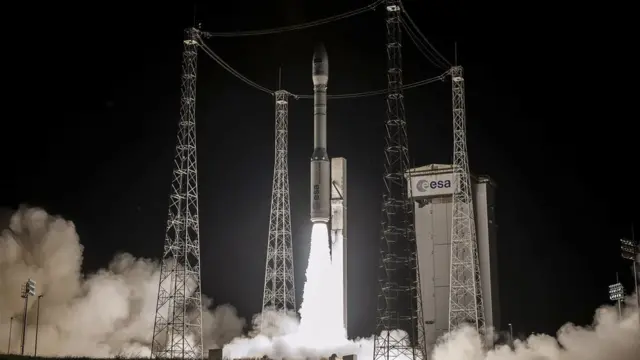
xmin=197 ymin=34 xmax=449 ymax=100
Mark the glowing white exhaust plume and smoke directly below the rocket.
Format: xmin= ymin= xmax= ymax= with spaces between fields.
xmin=223 ymin=224 xmax=362 ymax=359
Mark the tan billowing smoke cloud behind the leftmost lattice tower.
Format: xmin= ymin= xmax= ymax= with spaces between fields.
xmin=0 ymin=208 xmax=245 ymax=357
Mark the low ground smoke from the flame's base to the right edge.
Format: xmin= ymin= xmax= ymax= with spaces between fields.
xmin=223 ymin=301 xmax=640 ymax=360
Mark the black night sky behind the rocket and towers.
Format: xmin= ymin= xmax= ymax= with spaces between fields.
xmin=5 ymin=0 xmax=640 ymax=336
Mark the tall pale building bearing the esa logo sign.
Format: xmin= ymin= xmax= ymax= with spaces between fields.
xmin=410 ymin=164 xmax=500 ymax=350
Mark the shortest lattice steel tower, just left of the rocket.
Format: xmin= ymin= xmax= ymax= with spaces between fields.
xmin=262 ymin=90 xmax=296 ymax=312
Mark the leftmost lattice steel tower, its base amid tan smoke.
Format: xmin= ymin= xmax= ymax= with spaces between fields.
xmin=151 ymin=28 xmax=202 ymax=359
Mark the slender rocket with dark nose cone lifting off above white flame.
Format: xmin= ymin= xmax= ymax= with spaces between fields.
xmin=311 ymin=45 xmax=331 ymax=224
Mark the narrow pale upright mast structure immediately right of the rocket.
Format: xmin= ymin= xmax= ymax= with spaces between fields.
xmin=330 ymin=158 xmax=347 ymax=332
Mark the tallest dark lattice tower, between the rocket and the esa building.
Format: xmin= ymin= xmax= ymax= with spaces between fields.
xmin=373 ymin=0 xmax=426 ymax=360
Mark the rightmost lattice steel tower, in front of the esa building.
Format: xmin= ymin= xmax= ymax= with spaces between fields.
xmin=449 ymin=66 xmax=485 ymax=333
